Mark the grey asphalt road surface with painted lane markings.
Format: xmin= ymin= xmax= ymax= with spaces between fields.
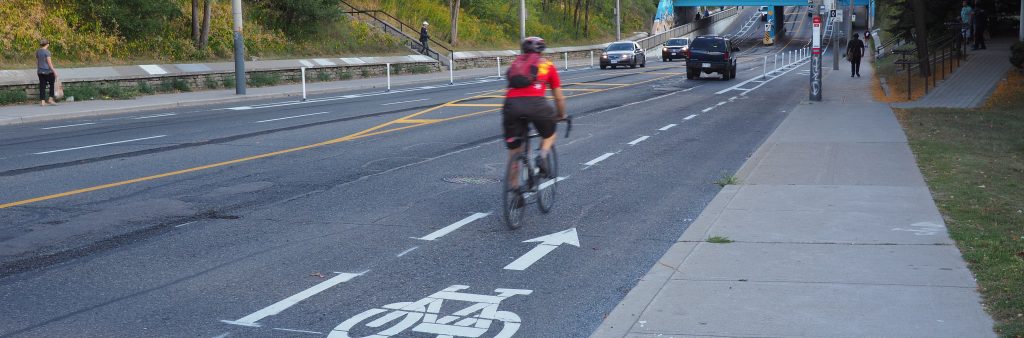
xmin=0 ymin=16 xmax=809 ymax=337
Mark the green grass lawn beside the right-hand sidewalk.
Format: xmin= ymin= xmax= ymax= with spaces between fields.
xmin=898 ymin=71 xmax=1024 ymax=337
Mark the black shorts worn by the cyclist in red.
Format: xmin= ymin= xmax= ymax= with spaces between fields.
xmin=502 ymin=96 xmax=558 ymax=150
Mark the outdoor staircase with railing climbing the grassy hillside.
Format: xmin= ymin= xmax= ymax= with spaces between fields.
xmin=341 ymin=1 xmax=454 ymax=66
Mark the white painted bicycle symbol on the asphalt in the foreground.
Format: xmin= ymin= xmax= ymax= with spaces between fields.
xmin=328 ymin=285 xmax=534 ymax=338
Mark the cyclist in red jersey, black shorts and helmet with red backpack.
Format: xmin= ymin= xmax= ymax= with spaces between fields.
xmin=502 ymin=37 xmax=565 ymax=207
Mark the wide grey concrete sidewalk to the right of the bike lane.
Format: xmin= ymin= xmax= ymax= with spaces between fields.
xmin=593 ymin=52 xmax=994 ymax=337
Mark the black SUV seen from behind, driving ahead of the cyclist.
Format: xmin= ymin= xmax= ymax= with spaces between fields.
xmin=686 ymin=36 xmax=739 ymax=80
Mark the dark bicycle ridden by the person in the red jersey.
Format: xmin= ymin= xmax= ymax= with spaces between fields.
xmin=502 ymin=117 xmax=572 ymax=229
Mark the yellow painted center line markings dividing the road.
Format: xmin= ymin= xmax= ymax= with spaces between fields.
xmin=0 ymin=76 xmax=669 ymax=209
